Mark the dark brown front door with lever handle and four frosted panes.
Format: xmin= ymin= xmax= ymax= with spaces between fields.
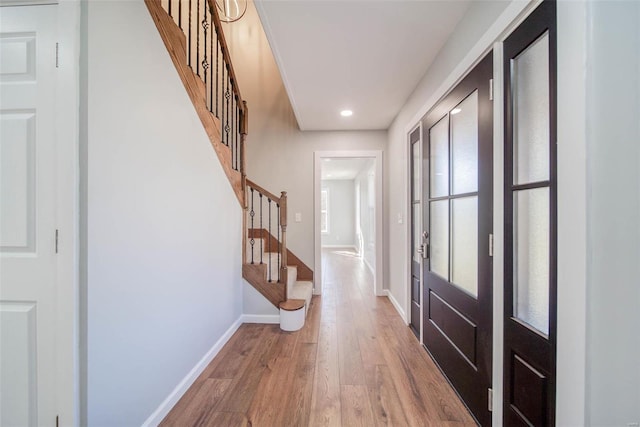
xmin=422 ymin=53 xmax=493 ymax=425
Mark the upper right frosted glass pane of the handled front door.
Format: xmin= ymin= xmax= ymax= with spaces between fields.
xmin=451 ymin=90 xmax=478 ymax=194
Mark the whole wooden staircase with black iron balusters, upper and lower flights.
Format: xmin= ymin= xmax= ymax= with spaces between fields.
xmin=145 ymin=0 xmax=313 ymax=328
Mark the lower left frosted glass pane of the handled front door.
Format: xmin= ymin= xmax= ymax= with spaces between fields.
xmin=429 ymin=200 xmax=449 ymax=280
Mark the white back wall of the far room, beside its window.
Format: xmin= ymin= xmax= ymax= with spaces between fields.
xmin=321 ymin=179 xmax=356 ymax=246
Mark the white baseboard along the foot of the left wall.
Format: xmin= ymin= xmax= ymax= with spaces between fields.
xmin=142 ymin=316 xmax=244 ymax=427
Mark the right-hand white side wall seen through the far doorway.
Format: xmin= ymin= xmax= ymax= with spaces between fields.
xmin=355 ymin=159 xmax=378 ymax=274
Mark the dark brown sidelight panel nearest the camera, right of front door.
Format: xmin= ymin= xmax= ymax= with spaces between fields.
xmin=504 ymin=1 xmax=556 ymax=426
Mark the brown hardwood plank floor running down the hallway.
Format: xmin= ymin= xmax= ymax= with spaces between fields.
xmin=161 ymin=250 xmax=476 ymax=427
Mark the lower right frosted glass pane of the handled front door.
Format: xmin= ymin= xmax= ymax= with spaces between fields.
xmin=451 ymin=196 xmax=478 ymax=297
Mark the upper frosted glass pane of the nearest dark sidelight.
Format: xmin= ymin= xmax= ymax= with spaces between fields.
xmin=511 ymin=33 xmax=549 ymax=184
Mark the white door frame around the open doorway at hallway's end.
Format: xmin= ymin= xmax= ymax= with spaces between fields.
xmin=313 ymin=150 xmax=386 ymax=296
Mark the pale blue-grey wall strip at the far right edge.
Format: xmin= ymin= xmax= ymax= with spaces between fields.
xmin=584 ymin=1 xmax=640 ymax=426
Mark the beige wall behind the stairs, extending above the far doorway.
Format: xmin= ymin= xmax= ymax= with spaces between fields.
xmin=224 ymin=2 xmax=387 ymax=269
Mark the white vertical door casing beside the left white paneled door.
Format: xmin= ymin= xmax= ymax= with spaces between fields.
xmin=56 ymin=0 xmax=80 ymax=426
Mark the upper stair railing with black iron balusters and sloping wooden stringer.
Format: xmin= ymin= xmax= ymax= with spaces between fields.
xmin=145 ymin=0 xmax=248 ymax=208
